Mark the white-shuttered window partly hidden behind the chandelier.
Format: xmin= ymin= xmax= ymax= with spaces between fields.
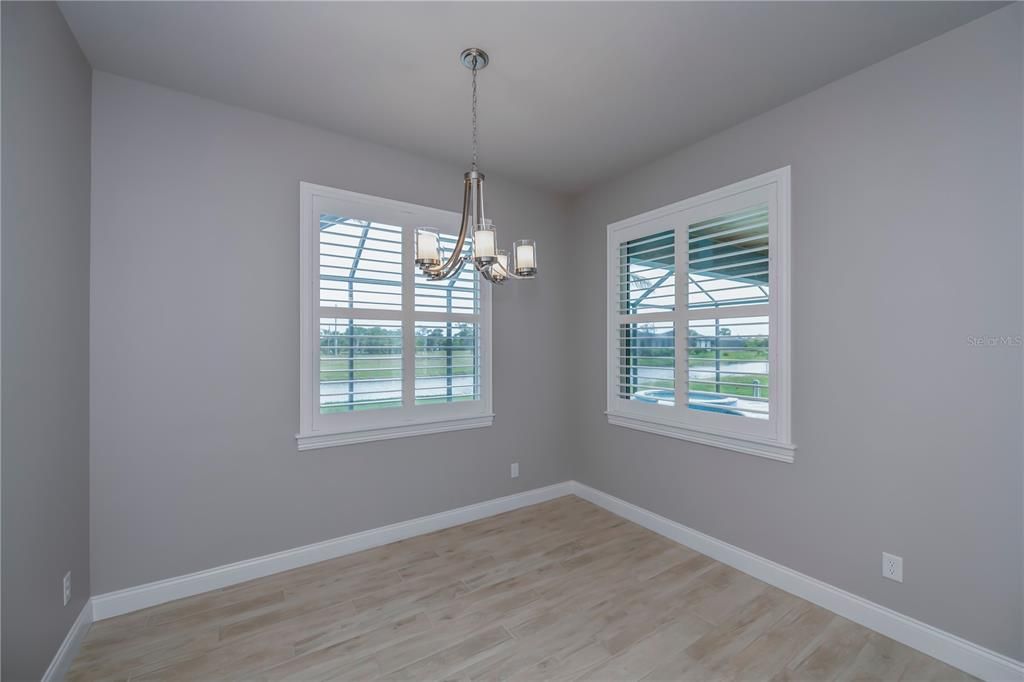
xmin=297 ymin=182 xmax=493 ymax=450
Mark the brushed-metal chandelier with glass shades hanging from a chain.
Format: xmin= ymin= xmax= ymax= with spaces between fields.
xmin=416 ymin=47 xmax=537 ymax=284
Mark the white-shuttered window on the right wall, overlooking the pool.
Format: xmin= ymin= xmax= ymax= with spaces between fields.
xmin=608 ymin=168 xmax=795 ymax=461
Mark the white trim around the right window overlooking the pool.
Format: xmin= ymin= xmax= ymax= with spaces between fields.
xmin=605 ymin=166 xmax=796 ymax=462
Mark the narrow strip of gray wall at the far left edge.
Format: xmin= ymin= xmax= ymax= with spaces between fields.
xmin=0 ymin=2 xmax=92 ymax=680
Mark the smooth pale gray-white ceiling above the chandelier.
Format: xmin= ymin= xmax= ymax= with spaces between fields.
xmin=61 ymin=2 xmax=1005 ymax=193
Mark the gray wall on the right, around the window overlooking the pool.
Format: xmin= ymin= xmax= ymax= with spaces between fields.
xmin=572 ymin=4 xmax=1024 ymax=658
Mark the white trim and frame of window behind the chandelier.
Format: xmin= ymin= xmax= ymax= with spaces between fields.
xmin=295 ymin=182 xmax=495 ymax=451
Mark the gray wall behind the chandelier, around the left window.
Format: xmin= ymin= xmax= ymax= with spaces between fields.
xmin=91 ymin=73 xmax=568 ymax=594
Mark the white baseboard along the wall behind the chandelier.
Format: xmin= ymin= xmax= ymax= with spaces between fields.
xmin=91 ymin=481 xmax=571 ymax=621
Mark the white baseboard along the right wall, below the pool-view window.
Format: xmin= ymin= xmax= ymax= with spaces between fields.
xmin=571 ymin=481 xmax=1024 ymax=682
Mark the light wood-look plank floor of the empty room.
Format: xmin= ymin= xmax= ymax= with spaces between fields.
xmin=69 ymin=497 xmax=967 ymax=681
